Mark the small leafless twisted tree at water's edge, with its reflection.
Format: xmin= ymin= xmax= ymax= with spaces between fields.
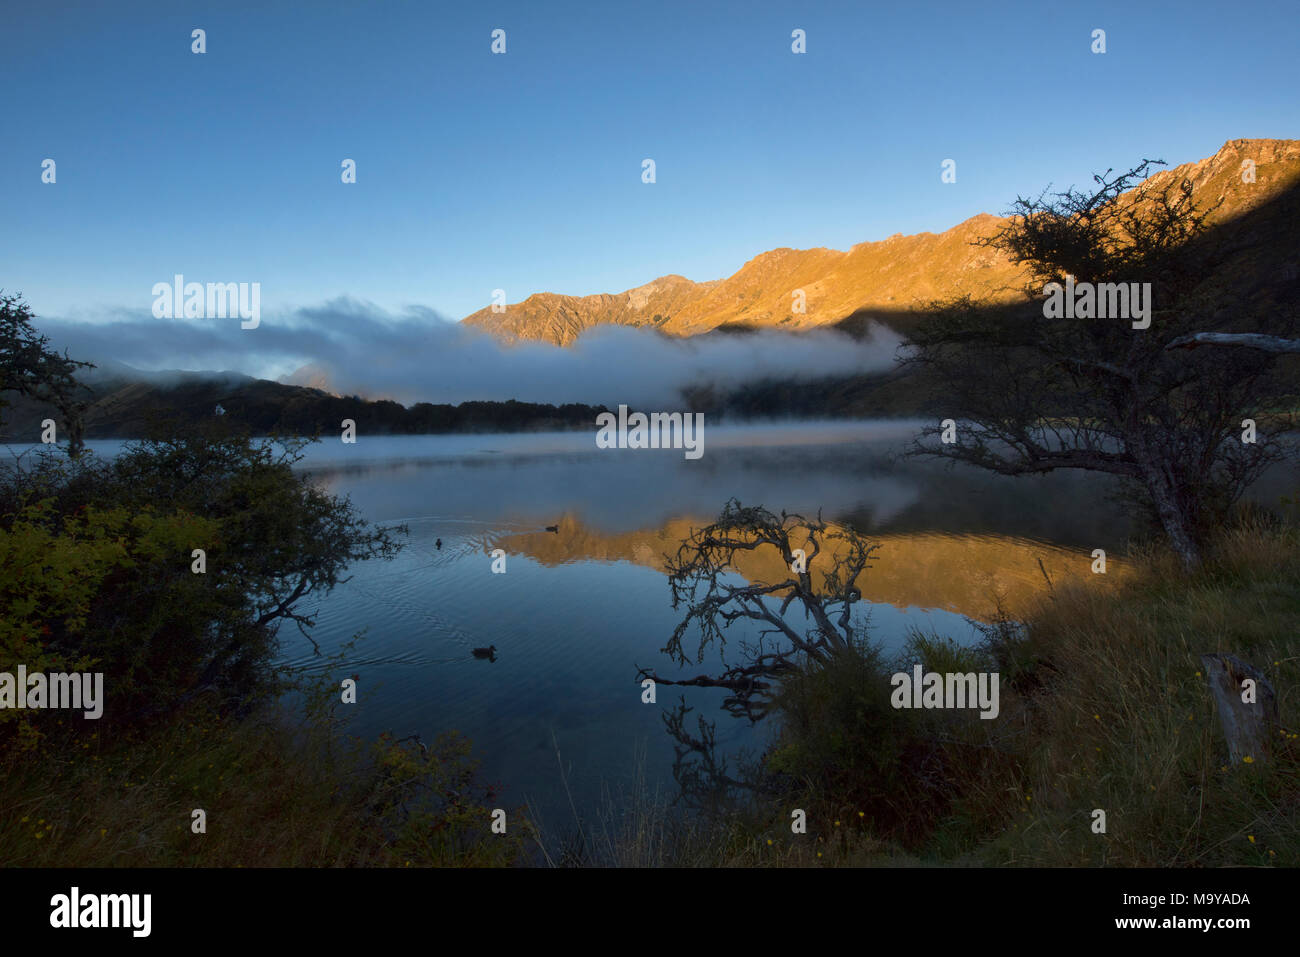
xmin=637 ymin=499 xmax=876 ymax=804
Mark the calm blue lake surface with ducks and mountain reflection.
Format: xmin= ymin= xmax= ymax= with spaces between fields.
xmin=269 ymin=423 xmax=1144 ymax=828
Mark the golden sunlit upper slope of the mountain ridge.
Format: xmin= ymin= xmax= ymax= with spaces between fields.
xmin=463 ymin=139 xmax=1300 ymax=346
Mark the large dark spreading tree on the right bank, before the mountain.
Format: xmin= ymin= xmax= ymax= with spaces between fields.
xmin=905 ymin=160 xmax=1295 ymax=568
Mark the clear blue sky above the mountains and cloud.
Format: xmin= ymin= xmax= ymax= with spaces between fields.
xmin=0 ymin=0 xmax=1300 ymax=327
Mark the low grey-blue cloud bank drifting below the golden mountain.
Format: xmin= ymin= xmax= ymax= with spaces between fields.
xmin=38 ymin=299 xmax=901 ymax=408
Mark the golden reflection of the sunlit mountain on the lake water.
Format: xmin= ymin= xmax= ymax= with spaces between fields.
xmin=488 ymin=515 xmax=1125 ymax=622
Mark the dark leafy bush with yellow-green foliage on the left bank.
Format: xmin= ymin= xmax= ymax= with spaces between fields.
xmin=0 ymin=432 xmax=398 ymax=738
